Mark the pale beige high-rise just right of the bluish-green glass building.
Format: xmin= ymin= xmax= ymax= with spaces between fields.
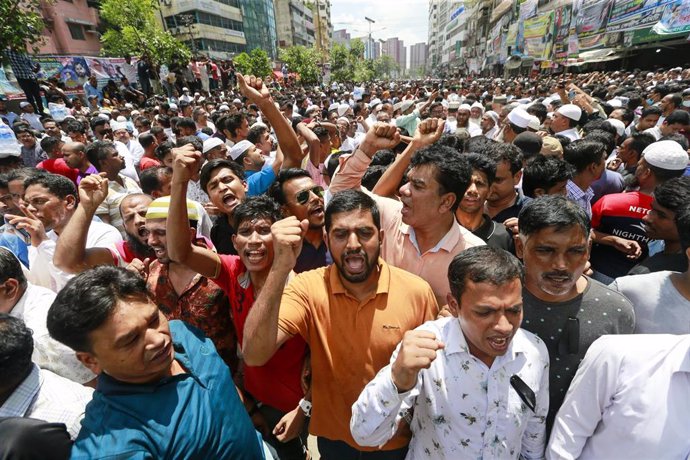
xmin=273 ymin=0 xmax=316 ymax=48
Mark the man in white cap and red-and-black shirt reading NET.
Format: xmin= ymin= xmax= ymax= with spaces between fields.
xmin=590 ymin=141 xmax=688 ymax=281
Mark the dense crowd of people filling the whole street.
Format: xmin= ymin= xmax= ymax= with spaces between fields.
xmin=0 ymin=63 xmax=690 ymax=460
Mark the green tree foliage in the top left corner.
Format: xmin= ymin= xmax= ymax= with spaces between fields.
xmin=0 ymin=0 xmax=53 ymax=51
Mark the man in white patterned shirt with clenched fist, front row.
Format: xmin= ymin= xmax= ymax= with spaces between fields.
xmin=350 ymin=246 xmax=549 ymax=459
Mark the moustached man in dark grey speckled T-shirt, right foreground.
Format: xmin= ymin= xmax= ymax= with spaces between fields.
xmin=515 ymin=195 xmax=635 ymax=431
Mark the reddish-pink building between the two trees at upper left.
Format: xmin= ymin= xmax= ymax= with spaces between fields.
xmin=38 ymin=0 xmax=101 ymax=56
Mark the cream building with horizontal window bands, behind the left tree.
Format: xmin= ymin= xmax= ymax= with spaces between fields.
xmin=160 ymin=0 xmax=246 ymax=59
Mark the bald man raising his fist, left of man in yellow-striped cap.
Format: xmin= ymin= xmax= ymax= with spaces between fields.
xmin=53 ymin=174 xmax=154 ymax=273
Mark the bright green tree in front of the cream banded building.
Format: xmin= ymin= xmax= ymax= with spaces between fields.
xmin=100 ymin=0 xmax=191 ymax=64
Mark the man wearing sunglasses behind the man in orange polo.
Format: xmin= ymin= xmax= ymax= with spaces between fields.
xmin=270 ymin=168 xmax=333 ymax=273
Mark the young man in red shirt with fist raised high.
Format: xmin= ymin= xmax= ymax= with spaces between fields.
xmin=167 ymin=157 xmax=307 ymax=458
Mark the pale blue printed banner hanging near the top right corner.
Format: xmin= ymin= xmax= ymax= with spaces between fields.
xmin=606 ymin=0 xmax=676 ymax=32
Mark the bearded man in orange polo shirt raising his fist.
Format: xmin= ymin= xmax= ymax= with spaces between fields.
xmin=242 ymin=190 xmax=438 ymax=460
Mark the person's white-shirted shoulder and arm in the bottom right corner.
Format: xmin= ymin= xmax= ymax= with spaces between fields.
xmin=546 ymin=334 xmax=690 ymax=460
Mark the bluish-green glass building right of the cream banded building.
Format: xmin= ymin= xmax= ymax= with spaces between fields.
xmin=241 ymin=0 xmax=278 ymax=59
